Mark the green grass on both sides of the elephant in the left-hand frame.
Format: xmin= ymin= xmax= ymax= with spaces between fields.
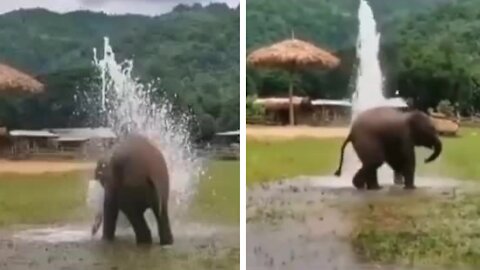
xmin=0 ymin=161 xmax=240 ymax=226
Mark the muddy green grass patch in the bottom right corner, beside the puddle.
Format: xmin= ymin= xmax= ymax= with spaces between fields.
xmin=352 ymin=194 xmax=480 ymax=267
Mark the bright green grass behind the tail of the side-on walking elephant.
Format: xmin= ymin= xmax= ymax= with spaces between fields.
xmin=246 ymin=138 xmax=344 ymax=185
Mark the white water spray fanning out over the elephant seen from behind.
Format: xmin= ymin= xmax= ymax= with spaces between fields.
xmin=88 ymin=37 xmax=201 ymax=213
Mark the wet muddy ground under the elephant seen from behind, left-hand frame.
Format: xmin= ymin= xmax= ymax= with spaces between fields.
xmin=0 ymin=218 xmax=239 ymax=269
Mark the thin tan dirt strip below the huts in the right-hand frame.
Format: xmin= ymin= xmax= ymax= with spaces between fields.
xmin=246 ymin=125 xmax=348 ymax=140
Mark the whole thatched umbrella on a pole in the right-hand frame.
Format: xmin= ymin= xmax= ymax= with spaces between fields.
xmin=247 ymin=35 xmax=340 ymax=125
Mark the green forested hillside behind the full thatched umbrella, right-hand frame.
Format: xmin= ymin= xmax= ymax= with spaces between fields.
xmin=247 ymin=0 xmax=480 ymax=113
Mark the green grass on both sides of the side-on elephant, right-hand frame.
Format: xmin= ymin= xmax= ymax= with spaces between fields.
xmin=246 ymin=128 xmax=480 ymax=184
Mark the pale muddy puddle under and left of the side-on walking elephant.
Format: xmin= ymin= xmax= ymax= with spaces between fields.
xmin=246 ymin=174 xmax=463 ymax=270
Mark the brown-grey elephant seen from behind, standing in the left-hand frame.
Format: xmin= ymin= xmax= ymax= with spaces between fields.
xmin=92 ymin=135 xmax=173 ymax=245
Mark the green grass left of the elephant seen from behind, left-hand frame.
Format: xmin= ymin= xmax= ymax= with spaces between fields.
xmin=0 ymin=172 xmax=87 ymax=226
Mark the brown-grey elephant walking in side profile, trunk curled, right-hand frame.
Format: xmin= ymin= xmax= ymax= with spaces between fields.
xmin=335 ymin=107 xmax=442 ymax=189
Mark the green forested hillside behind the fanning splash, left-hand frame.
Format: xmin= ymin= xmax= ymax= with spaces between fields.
xmin=0 ymin=4 xmax=239 ymax=130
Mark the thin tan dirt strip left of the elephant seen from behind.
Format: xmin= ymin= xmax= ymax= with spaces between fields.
xmin=0 ymin=160 xmax=95 ymax=174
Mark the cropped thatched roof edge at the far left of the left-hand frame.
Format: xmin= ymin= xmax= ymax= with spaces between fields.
xmin=0 ymin=64 xmax=44 ymax=93
